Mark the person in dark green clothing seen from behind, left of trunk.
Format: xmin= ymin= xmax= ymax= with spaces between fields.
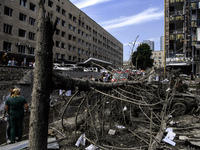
xmin=5 ymin=88 xmax=28 ymax=143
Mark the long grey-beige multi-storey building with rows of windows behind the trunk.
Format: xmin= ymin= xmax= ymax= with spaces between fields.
xmin=0 ymin=0 xmax=123 ymax=68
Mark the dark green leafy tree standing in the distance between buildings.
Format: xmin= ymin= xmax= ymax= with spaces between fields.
xmin=132 ymin=44 xmax=153 ymax=70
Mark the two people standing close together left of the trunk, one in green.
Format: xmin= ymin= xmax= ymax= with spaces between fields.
xmin=3 ymin=87 xmax=28 ymax=143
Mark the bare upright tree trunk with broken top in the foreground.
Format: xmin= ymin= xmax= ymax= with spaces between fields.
xmin=29 ymin=0 xmax=54 ymax=150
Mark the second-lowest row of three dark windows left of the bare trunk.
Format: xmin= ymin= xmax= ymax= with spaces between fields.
xmin=4 ymin=24 xmax=35 ymax=40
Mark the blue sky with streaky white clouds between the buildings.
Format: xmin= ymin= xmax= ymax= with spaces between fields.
xmin=70 ymin=0 xmax=164 ymax=60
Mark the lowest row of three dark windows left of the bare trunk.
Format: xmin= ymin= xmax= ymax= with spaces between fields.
xmin=3 ymin=41 xmax=35 ymax=55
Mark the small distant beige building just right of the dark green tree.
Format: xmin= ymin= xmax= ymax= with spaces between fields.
xmin=151 ymin=51 xmax=164 ymax=68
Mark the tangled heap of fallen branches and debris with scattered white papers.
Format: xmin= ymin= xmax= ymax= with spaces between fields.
xmin=49 ymin=70 xmax=199 ymax=150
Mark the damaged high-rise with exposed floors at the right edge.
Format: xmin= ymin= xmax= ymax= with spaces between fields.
xmin=164 ymin=0 xmax=200 ymax=75
